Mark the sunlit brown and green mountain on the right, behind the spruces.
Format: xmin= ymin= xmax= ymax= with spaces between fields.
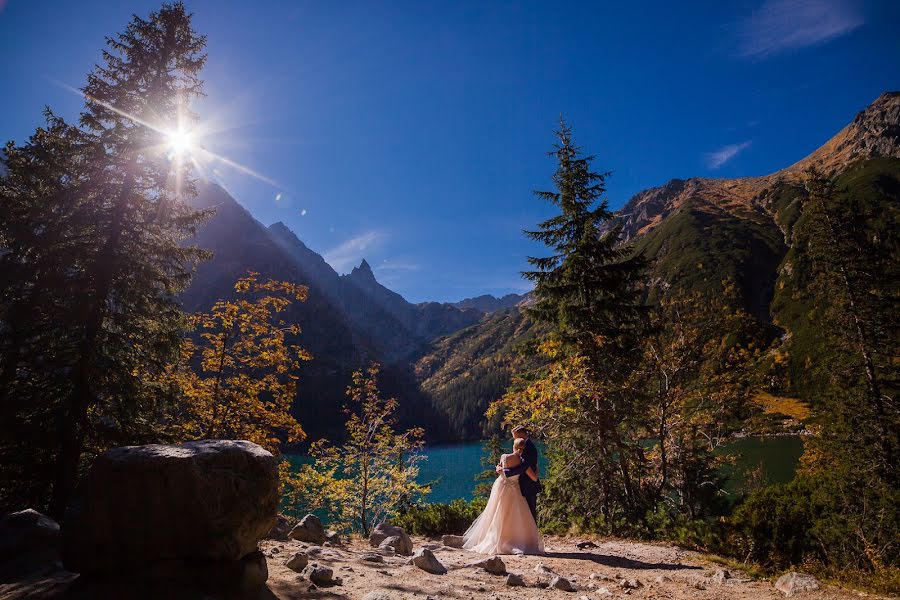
xmin=416 ymin=92 xmax=900 ymax=437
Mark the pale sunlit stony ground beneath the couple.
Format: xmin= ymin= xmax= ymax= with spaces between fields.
xmin=255 ymin=538 xmax=864 ymax=600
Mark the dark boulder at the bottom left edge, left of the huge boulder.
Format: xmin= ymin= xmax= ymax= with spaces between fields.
xmin=0 ymin=508 xmax=61 ymax=581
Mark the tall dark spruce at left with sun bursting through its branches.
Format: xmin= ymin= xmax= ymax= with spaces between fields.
xmin=0 ymin=2 xmax=205 ymax=517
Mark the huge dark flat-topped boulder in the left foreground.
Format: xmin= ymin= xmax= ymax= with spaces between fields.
xmin=62 ymin=440 xmax=279 ymax=574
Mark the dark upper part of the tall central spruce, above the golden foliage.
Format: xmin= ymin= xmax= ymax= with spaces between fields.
xmin=523 ymin=119 xmax=646 ymax=368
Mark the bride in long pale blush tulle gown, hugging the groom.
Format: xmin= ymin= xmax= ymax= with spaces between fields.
xmin=463 ymin=439 xmax=544 ymax=554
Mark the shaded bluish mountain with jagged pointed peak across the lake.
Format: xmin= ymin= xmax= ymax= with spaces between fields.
xmin=181 ymin=182 xmax=484 ymax=440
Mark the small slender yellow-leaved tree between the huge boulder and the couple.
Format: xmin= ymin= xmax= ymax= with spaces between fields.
xmin=283 ymin=363 xmax=429 ymax=536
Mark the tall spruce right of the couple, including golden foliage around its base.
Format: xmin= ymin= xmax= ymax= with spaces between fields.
xmin=490 ymin=120 xmax=646 ymax=530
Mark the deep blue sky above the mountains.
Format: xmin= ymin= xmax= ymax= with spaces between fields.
xmin=0 ymin=0 xmax=900 ymax=301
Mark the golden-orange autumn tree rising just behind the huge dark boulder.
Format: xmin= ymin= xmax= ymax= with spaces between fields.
xmin=166 ymin=272 xmax=311 ymax=453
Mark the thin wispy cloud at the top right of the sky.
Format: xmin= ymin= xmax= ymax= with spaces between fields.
xmin=738 ymin=0 xmax=864 ymax=59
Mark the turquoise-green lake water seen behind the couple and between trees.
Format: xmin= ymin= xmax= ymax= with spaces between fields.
xmin=286 ymin=436 xmax=803 ymax=503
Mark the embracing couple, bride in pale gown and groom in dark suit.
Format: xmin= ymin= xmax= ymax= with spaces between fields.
xmin=463 ymin=425 xmax=544 ymax=554
